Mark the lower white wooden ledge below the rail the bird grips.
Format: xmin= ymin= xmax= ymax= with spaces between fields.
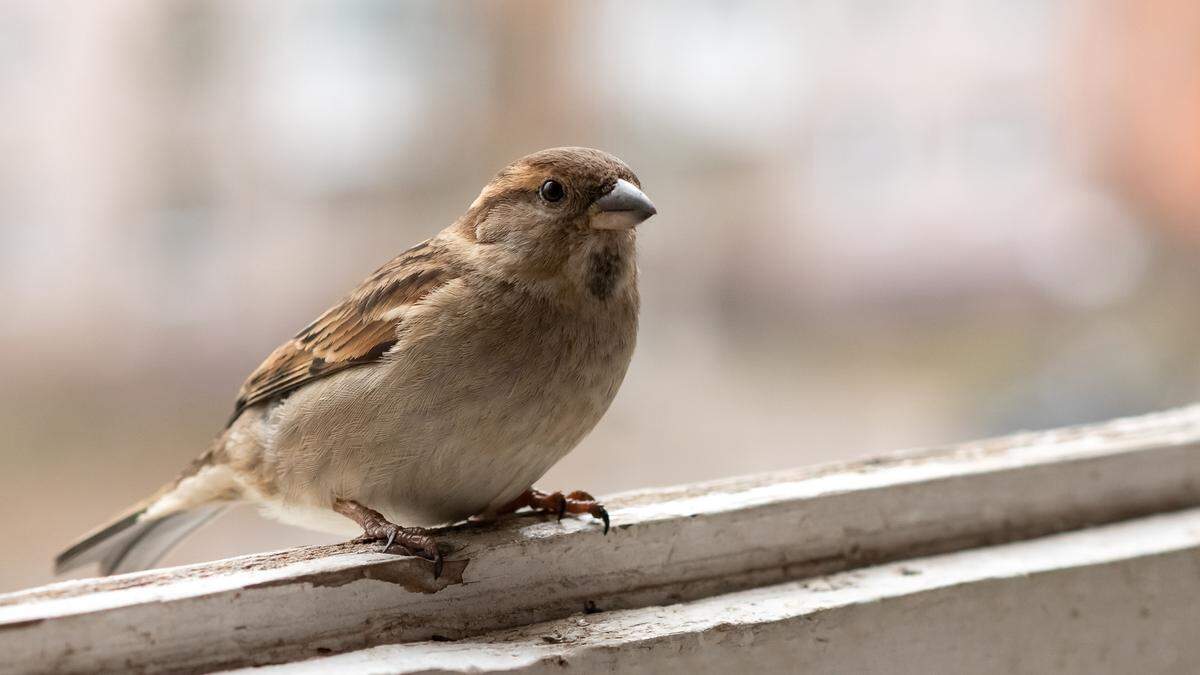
xmin=226 ymin=509 xmax=1200 ymax=675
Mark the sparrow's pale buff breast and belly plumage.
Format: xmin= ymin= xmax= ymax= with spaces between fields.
xmin=146 ymin=234 xmax=637 ymax=534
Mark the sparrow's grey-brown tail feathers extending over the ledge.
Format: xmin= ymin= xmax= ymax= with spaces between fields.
xmin=54 ymin=503 xmax=228 ymax=575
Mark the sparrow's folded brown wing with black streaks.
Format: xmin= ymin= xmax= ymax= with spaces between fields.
xmin=229 ymin=241 xmax=455 ymax=424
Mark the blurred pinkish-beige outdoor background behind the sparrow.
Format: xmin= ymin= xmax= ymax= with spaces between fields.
xmin=0 ymin=0 xmax=1200 ymax=591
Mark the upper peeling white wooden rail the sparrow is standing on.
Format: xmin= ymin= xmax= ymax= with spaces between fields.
xmin=0 ymin=407 xmax=1200 ymax=671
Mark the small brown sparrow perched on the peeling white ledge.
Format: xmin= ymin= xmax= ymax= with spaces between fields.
xmin=55 ymin=148 xmax=656 ymax=577
